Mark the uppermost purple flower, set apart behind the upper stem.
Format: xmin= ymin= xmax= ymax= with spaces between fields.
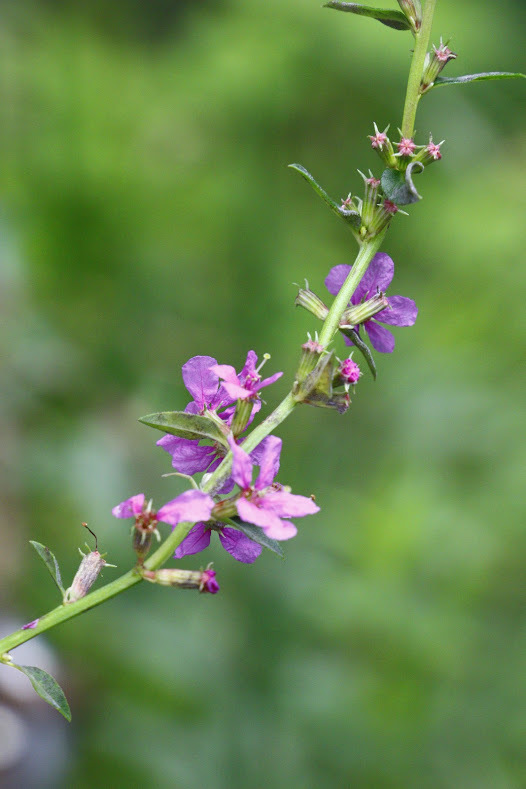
xmin=325 ymin=252 xmax=418 ymax=353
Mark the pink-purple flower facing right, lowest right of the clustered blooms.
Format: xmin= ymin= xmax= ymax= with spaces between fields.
xmin=230 ymin=436 xmax=319 ymax=540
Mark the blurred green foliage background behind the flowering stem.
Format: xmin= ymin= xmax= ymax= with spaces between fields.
xmin=0 ymin=0 xmax=526 ymax=789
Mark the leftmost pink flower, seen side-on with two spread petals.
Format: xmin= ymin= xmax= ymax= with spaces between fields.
xmin=111 ymin=490 xmax=214 ymax=529
